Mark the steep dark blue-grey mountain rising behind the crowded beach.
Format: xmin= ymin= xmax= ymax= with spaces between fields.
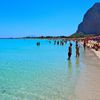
xmin=76 ymin=3 xmax=100 ymax=35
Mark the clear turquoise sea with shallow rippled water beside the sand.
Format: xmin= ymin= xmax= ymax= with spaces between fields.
xmin=0 ymin=39 xmax=84 ymax=100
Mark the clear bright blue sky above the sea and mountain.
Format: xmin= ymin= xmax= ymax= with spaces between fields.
xmin=0 ymin=0 xmax=100 ymax=37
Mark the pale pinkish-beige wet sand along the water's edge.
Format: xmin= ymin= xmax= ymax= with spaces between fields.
xmin=75 ymin=50 xmax=100 ymax=100
